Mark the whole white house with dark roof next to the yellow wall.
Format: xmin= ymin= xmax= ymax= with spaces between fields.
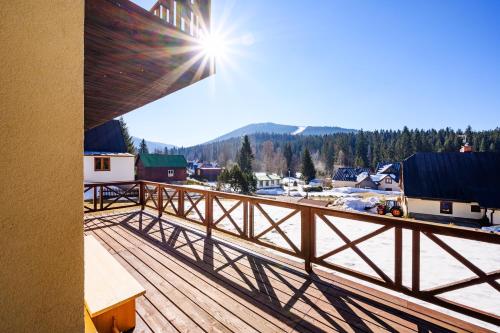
xmin=83 ymin=120 xmax=135 ymax=183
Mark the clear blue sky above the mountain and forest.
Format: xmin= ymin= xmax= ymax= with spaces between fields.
xmin=125 ymin=0 xmax=500 ymax=146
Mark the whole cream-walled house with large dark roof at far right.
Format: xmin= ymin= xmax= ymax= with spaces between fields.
xmin=402 ymin=152 xmax=500 ymax=224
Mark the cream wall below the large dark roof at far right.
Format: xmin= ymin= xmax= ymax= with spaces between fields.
xmin=406 ymin=198 xmax=484 ymax=219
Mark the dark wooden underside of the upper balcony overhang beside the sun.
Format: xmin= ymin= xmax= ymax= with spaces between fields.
xmin=84 ymin=0 xmax=214 ymax=129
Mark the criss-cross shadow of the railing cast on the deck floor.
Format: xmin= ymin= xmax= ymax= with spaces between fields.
xmin=85 ymin=211 xmax=460 ymax=332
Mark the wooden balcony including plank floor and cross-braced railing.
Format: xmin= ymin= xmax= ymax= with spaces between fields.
xmin=84 ymin=181 xmax=500 ymax=332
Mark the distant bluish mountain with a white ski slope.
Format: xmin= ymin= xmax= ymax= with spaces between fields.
xmin=207 ymin=123 xmax=356 ymax=143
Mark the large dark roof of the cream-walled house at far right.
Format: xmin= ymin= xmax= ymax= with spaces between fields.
xmin=403 ymin=152 xmax=500 ymax=208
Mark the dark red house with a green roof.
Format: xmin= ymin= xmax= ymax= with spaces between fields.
xmin=135 ymin=154 xmax=187 ymax=183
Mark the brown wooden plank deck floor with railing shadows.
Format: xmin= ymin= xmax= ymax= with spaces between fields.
xmin=85 ymin=211 xmax=492 ymax=332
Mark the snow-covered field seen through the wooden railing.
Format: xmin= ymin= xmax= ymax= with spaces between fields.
xmin=178 ymin=193 xmax=500 ymax=332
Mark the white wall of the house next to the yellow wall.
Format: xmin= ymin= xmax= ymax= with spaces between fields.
xmin=83 ymin=155 xmax=135 ymax=183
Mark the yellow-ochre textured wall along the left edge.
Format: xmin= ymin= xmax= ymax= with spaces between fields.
xmin=0 ymin=0 xmax=84 ymax=332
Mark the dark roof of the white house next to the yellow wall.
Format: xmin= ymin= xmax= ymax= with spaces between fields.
xmin=83 ymin=120 xmax=127 ymax=153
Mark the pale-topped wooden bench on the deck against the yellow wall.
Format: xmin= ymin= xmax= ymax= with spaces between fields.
xmin=84 ymin=236 xmax=146 ymax=333
